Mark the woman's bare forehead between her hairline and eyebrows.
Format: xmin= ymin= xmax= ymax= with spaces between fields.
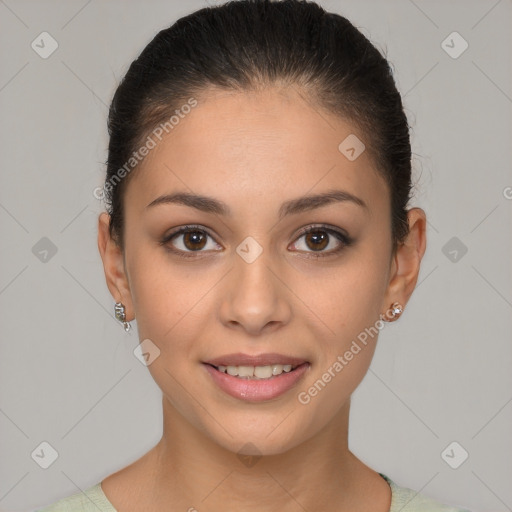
xmin=126 ymin=88 xmax=387 ymax=216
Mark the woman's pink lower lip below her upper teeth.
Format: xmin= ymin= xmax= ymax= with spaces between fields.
xmin=204 ymin=363 xmax=309 ymax=402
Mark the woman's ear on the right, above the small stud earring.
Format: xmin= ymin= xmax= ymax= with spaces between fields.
xmin=382 ymin=208 xmax=427 ymax=311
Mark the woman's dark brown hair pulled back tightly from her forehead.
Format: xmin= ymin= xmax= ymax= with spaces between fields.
xmin=104 ymin=0 xmax=411 ymax=247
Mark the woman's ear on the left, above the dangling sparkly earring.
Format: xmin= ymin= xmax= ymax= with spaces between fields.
xmin=98 ymin=212 xmax=135 ymax=322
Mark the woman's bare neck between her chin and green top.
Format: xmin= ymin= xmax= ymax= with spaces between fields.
xmin=131 ymin=397 xmax=384 ymax=512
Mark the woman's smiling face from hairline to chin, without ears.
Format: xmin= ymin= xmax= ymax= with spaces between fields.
xmin=105 ymin=89 xmax=403 ymax=454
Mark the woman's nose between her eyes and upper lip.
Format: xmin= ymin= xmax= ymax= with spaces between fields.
xmin=220 ymin=247 xmax=291 ymax=336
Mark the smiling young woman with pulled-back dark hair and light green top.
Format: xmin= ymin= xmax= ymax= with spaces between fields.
xmin=39 ymin=0 xmax=472 ymax=512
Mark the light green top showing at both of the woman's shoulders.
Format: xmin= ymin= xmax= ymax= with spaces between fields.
xmin=36 ymin=473 xmax=470 ymax=512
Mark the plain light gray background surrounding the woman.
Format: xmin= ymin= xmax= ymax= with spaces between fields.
xmin=0 ymin=0 xmax=512 ymax=511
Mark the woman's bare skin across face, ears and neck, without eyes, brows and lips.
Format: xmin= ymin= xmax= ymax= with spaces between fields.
xmin=98 ymin=88 xmax=426 ymax=512
